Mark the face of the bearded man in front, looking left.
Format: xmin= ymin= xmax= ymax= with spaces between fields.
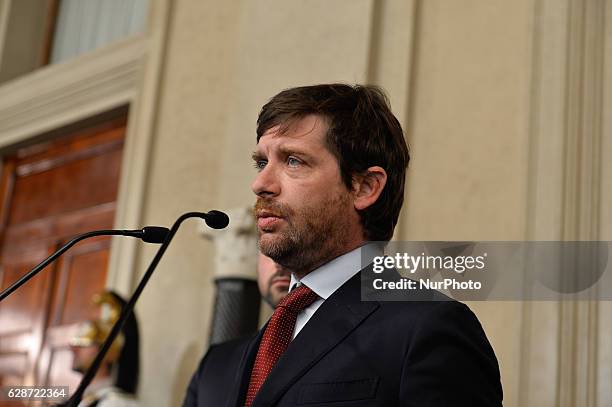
xmin=252 ymin=115 xmax=363 ymax=276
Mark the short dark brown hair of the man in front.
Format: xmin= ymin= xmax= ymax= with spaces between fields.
xmin=257 ymin=84 xmax=410 ymax=241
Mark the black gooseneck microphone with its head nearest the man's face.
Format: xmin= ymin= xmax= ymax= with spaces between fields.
xmin=62 ymin=211 xmax=227 ymax=407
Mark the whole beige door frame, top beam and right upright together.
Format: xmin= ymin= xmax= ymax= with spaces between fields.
xmin=0 ymin=0 xmax=172 ymax=295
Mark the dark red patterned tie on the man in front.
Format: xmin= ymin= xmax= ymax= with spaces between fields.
xmin=244 ymin=284 xmax=319 ymax=407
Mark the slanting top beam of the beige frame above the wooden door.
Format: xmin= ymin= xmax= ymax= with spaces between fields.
xmin=0 ymin=36 xmax=146 ymax=148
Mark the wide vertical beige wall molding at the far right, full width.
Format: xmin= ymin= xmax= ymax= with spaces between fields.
xmin=519 ymin=0 xmax=605 ymax=407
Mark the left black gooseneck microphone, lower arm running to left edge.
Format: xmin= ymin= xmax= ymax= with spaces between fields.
xmin=0 ymin=226 xmax=170 ymax=301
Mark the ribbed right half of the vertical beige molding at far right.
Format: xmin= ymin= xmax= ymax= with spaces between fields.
xmin=559 ymin=0 xmax=605 ymax=407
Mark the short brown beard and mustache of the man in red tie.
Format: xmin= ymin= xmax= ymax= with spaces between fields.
xmin=254 ymin=193 xmax=350 ymax=277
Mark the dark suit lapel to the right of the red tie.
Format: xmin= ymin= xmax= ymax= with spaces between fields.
xmin=253 ymin=273 xmax=379 ymax=407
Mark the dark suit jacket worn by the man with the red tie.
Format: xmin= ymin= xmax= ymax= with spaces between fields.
xmin=183 ymin=273 xmax=502 ymax=407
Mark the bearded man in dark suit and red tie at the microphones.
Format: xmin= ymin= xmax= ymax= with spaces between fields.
xmin=184 ymin=84 xmax=502 ymax=407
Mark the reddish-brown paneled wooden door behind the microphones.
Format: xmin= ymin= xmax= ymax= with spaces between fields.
xmin=0 ymin=118 xmax=125 ymax=402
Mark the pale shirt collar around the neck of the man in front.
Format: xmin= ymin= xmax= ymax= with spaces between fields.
xmin=289 ymin=244 xmax=382 ymax=300
